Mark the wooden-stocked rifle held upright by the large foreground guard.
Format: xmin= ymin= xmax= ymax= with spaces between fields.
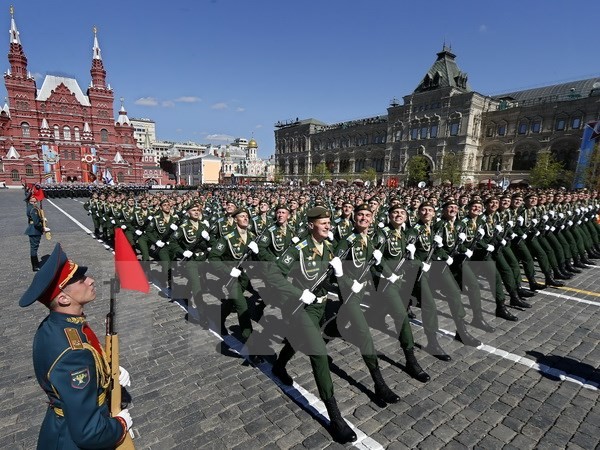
xmin=104 ymin=277 xmax=135 ymax=450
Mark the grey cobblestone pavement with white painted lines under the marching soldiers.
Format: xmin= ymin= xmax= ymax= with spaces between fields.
xmin=0 ymin=190 xmax=600 ymax=449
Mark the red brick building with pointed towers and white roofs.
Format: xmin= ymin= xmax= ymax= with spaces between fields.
xmin=0 ymin=7 xmax=149 ymax=185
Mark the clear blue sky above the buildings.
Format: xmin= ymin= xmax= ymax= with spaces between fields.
xmin=0 ymin=0 xmax=600 ymax=157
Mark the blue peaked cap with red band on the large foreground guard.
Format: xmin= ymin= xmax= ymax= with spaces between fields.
xmin=19 ymin=243 xmax=87 ymax=307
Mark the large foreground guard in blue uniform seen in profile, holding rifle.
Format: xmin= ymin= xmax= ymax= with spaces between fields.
xmin=19 ymin=244 xmax=132 ymax=450
